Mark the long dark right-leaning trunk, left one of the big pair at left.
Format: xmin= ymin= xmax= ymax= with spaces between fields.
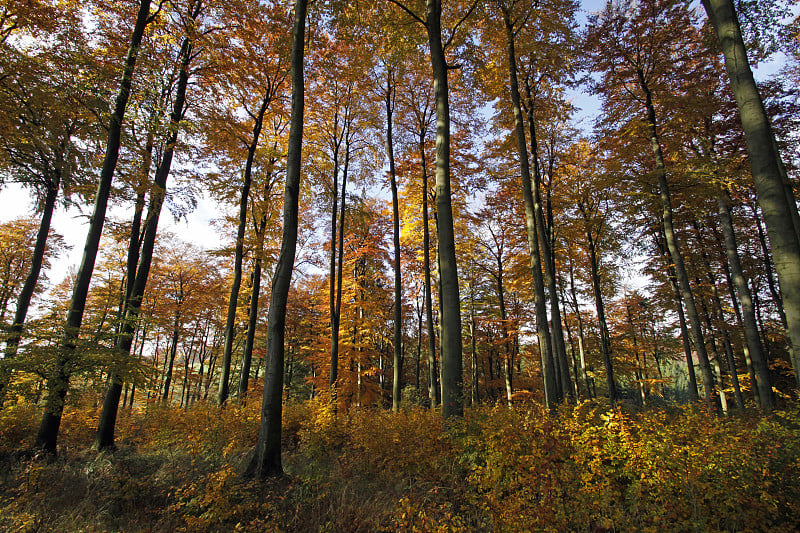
xmin=36 ymin=0 xmax=150 ymax=454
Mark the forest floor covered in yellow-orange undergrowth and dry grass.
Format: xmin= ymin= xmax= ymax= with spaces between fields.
xmin=0 ymin=393 xmax=800 ymax=532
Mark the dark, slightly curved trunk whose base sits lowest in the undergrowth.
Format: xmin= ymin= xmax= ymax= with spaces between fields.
xmin=245 ymin=0 xmax=308 ymax=478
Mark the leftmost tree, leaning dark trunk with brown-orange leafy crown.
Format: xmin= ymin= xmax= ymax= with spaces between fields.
xmin=0 ymin=4 xmax=101 ymax=396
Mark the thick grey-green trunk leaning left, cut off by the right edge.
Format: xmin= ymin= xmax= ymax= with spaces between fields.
xmin=703 ymin=0 xmax=800 ymax=385
